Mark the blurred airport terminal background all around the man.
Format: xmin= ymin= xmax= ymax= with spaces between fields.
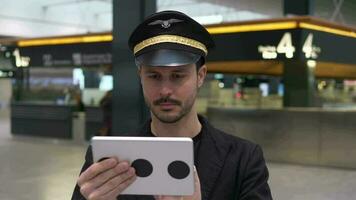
xmin=0 ymin=0 xmax=356 ymax=200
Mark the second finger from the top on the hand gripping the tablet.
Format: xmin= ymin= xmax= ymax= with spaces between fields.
xmin=80 ymin=161 xmax=130 ymax=194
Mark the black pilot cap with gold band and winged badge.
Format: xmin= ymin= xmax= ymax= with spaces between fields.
xmin=129 ymin=11 xmax=214 ymax=67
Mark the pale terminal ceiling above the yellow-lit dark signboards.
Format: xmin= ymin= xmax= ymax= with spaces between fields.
xmin=0 ymin=0 xmax=356 ymax=38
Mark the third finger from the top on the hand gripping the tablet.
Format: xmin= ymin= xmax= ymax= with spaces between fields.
xmin=89 ymin=167 xmax=135 ymax=199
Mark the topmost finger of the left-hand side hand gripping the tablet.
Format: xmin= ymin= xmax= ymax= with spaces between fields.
xmin=77 ymin=158 xmax=118 ymax=186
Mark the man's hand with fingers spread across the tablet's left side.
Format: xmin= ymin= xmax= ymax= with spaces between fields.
xmin=77 ymin=158 xmax=136 ymax=200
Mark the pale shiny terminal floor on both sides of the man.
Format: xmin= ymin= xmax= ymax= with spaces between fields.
xmin=0 ymin=114 xmax=356 ymax=200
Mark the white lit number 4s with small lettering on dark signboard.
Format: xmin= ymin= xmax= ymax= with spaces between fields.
xmin=258 ymin=32 xmax=321 ymax=59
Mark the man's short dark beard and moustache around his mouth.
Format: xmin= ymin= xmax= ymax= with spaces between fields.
xmin=145 ymin=92 xmax=196 ymax=123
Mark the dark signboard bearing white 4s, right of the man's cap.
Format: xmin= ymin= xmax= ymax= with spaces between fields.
xmin=208 ymin=29 xmax=356 ymax=64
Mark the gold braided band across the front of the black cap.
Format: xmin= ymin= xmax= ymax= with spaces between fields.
xmin=134 ymin=35 xmax=208 ymax=56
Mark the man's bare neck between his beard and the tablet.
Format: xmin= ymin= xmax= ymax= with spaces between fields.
xmin=151 ymin=112 xmax=201 ymax=138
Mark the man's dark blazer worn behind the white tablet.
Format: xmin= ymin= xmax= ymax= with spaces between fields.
xmin=72 ymin=116 xmax=272 ymax=200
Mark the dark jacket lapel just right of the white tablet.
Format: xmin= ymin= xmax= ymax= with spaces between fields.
xmin=197 ymin=117 xmax=231 ymax=199
